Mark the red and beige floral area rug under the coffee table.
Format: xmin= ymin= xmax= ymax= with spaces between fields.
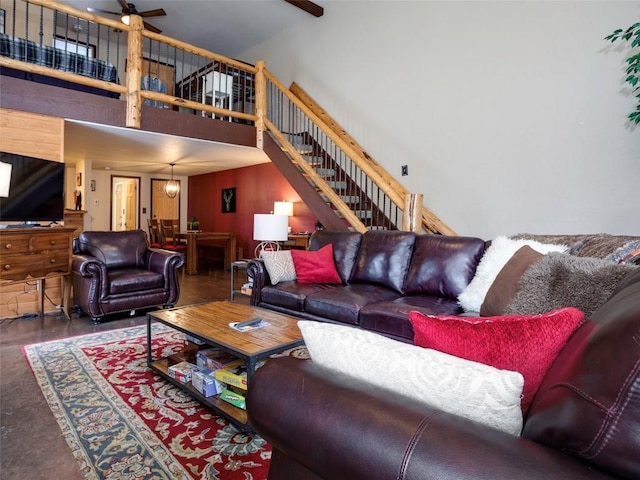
xmin=23 ymin=325 xmax=308 ymax=480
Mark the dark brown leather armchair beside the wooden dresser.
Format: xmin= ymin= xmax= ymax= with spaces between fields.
xmin=71 ymin=230 xmax=184 ymax=323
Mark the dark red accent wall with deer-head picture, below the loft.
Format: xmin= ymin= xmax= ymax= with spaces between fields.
xmin=188 ymin=163 xmax=317 ymax=257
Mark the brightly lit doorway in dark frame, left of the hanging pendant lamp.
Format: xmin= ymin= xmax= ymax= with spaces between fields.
xmin=111 ymin=175 xmax=140 ymax=232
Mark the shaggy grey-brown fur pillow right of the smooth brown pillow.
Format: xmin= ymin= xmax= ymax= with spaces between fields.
xmin=504 ymin=253 xmax=638 ymax=316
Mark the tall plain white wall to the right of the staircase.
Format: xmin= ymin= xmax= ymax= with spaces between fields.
xmin=241 ymin=0 xmax=640 ymax=239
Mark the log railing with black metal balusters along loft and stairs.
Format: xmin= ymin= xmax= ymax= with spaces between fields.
xmin=0 ymin=0 xmax=455 ymax=235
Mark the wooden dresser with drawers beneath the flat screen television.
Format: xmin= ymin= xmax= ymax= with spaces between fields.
xmin=0 ymin=227 xmax=75 ymax=317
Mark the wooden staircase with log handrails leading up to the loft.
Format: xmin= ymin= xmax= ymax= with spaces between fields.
xmin=265 ymin=71 xmax=455 ymax=235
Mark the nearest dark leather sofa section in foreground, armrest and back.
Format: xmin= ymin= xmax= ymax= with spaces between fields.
xmin=247 ymin=269 xmax=640 ymax=480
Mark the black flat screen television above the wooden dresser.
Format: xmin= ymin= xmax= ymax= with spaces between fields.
xmin=0 ymin=152 xmax=64 ymax=224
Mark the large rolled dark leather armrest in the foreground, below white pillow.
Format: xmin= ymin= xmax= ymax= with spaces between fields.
xmin=247 ymin=357 xmax=612 ymax=480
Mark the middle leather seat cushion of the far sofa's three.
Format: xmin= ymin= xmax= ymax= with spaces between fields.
xmin=304 ymin=283 xmax=398 ymax=325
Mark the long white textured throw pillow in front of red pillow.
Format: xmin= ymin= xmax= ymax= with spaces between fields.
xmin=298 ymin=320 xmax=524 ymax=435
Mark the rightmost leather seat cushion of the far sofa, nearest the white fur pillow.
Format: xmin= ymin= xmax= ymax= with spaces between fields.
xmin=360 ymin=294 xmax=462 ymax=343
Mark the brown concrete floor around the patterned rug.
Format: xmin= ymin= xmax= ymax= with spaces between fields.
xmin=0 ymin=270 xmax=235 ymax=480
